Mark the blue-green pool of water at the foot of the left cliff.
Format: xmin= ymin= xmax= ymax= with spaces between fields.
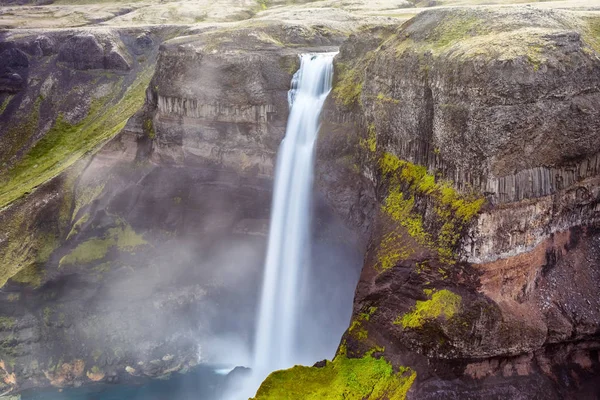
xmin=21 ymin=367 xmax=232 ymax=400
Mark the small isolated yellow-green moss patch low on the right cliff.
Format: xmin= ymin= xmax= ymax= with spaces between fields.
xmin=394 ymin=289 xmax=462 ymax=328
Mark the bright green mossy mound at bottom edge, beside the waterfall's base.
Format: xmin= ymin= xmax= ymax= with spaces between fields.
xmin=254 ymin=353 xmax=417 ymax=400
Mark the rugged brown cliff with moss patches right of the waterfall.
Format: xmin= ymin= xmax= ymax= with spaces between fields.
xmin=257 ymin=8 xmax=600 ymax=399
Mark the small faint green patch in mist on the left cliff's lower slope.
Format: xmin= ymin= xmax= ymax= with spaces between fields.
xmin=59 ymin=221 xmax=148 ymax=266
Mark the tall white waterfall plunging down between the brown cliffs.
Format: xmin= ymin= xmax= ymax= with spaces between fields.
xmin=254 ymin=53 xmax=336 ymax=374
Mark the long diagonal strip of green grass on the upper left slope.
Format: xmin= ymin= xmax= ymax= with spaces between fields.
xmin=0 ymin=69 xmax=152 ymax=207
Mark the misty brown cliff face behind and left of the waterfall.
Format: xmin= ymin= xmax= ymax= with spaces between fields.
xmin=0 ymin=23 xmax=360 ymax=391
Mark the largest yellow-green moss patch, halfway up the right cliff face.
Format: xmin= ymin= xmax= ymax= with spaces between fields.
xmin=376 ymin=153 xmax=485 ymax=270
